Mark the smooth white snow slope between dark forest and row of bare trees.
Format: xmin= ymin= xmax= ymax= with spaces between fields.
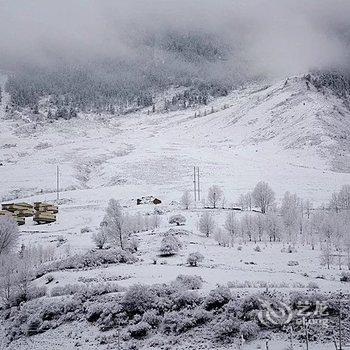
xmin=0 ymin=77 xmax=350 ymax=204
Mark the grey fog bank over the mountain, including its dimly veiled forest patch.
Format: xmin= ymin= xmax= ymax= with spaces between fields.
xmin=0 ymin=0 xmax=350 ymax=110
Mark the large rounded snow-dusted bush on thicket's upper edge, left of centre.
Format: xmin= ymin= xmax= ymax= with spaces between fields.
xmin=122 ymin=284 xmax=156 ymax=315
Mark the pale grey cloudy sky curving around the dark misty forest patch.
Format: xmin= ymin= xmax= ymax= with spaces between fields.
xmin=0 ymin=0 xmax=350 ymax=75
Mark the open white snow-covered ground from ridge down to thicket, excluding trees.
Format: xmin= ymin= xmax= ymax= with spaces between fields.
xmin=0 ymin=74 xmax=350 ymax=350
